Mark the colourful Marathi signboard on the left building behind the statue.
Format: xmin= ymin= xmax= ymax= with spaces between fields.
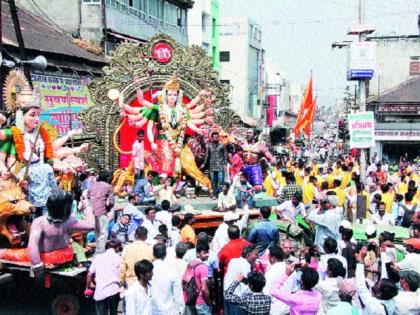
xmin=31 ymin=74 xmax=93 ymax=136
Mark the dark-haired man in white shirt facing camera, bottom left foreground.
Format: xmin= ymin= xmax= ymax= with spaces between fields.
xmin=125 ymin=259 xmax=153 ymax=315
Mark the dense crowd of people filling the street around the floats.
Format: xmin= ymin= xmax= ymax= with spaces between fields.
xmin=65 ymin=128 xmax=420 ymax=315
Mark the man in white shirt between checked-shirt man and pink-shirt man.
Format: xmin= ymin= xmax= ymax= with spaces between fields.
xmin=263 ymin=245 xmax=290 ymax=315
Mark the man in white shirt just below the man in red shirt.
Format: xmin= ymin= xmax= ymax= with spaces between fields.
xmin=223 ymin=245 xmax=258 ymax=314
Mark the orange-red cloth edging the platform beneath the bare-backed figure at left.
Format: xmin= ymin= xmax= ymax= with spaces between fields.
xmin=1 ymin=247 xmax=73 ymax=265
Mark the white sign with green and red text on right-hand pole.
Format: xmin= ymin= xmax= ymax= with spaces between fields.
xmin=348 ymin=112 xmax=375 ymax=149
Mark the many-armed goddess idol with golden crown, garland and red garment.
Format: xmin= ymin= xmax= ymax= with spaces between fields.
xmin=119 ymin=76 xmax=213 ymax=186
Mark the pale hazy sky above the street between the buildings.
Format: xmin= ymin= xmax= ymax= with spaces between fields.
xmin=219 ymin=0 xmax=420 ymax=106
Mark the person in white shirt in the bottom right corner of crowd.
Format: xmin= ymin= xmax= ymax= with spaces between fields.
xmin=395 ymin=270 xmax=420 ymax=315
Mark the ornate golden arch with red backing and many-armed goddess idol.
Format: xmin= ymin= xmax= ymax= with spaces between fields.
xmin=80 ymin=34 xmax=240 ymax=189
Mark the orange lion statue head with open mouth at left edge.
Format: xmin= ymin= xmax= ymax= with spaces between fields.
xmin=0 ymin=179 xmax=34 ymax=248
